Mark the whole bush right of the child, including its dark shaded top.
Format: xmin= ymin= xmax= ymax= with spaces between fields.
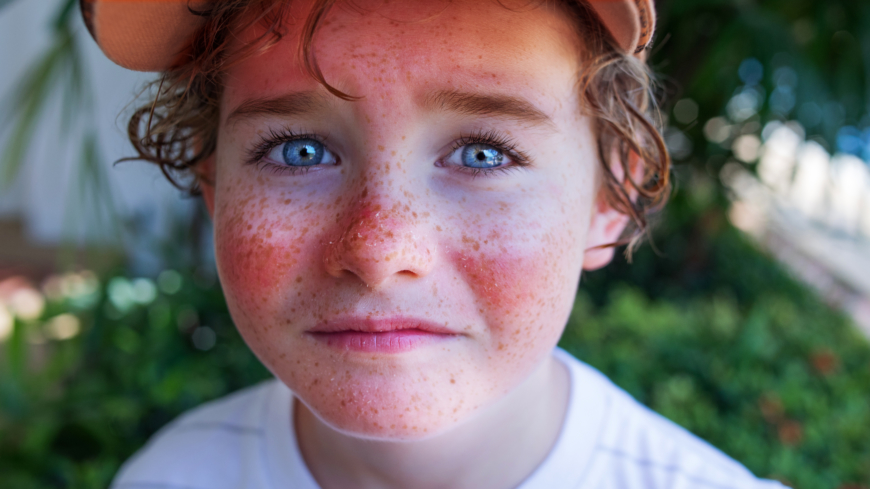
xmin=576 ymin=201 xmax=870 ymax=489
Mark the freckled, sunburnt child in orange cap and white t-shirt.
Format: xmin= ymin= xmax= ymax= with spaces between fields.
xmin=82 ymin=0 xmax=781 ymax=489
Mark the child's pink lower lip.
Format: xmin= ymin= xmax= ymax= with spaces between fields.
xmin=312 ymin=329 xmax=455 ymax=353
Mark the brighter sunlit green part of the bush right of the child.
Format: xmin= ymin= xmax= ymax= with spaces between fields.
xmin=562 ymin=287 xmax=870 ymax=489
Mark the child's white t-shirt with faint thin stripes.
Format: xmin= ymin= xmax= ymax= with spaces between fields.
xmin=112 ymin=349 xmax=784 ymax=489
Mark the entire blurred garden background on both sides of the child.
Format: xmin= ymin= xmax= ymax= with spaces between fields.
xmin=0 ymin=0 xmax=870 ymax=489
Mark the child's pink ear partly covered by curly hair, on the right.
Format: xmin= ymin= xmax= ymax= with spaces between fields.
xmin=583 ymin=149 xmax=643 ymax=271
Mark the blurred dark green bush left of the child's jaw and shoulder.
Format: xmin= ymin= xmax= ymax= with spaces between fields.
xmin=0 ymin=272 xmax=268 ymax=489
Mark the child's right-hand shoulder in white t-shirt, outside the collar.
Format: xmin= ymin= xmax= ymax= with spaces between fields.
xmin=563 ymin=348 xmax=783 ymax=489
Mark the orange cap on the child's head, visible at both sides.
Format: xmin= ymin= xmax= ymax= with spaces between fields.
xmin=80 ymin=0 xmax=655 ymax=71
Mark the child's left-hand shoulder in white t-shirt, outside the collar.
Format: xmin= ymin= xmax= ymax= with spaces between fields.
xmin=111 ymin=380 xmax=280 ymax=489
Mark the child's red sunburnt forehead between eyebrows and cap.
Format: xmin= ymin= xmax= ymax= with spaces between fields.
xmin=224 ymin=0 xmax=582 ymax=113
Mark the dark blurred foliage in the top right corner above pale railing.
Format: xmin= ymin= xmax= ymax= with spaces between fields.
xmin=650 ymin=0 xmax=870 ymax=192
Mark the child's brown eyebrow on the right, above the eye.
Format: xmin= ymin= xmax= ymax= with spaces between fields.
xmin=423 ymin=90 xmax=556 ymax=128
